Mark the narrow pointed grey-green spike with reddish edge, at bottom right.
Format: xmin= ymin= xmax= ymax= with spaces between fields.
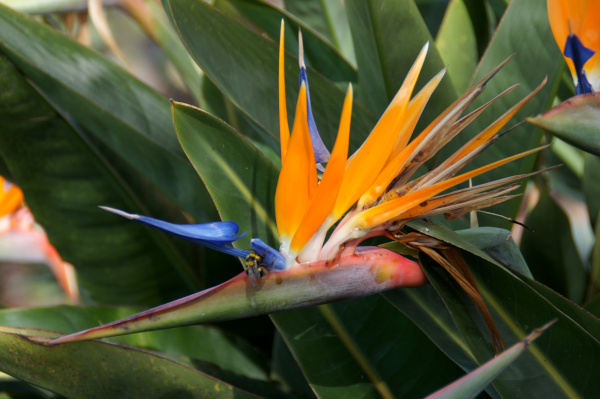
xmin=427 ymin=322 xmax=554 ymax=399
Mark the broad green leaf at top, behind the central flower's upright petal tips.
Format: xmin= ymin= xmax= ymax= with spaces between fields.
xmin=165 ymin=0 xmax=376 ymax=149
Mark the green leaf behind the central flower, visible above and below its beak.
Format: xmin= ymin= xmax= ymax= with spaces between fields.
xmin=173 ymin=103 xmax=458 ymax=397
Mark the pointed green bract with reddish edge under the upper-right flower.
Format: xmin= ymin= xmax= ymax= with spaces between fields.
xmin=527 ymin=93 xmax=600 ymax=156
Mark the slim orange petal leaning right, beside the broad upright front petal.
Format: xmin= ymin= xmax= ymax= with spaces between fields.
xmin=290 ymin=85 xmax=352 ymax=253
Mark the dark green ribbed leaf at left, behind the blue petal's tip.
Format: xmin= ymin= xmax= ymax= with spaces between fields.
xmin=0 ymin=58 xmax=194 ymax=305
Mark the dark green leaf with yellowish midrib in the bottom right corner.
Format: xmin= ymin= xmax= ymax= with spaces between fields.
xmin=426 ymin=254 xmax=600 ymax=398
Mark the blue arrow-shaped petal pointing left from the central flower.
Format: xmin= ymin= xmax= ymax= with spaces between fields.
xmin=100 ymin=206 xmax=250 ymax=258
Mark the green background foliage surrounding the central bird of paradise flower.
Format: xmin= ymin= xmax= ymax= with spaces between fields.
xmin=0 ymin=0 xmax=600 ymax=398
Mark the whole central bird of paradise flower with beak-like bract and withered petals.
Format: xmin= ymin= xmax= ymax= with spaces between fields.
xmin=52 ymin=25 xmax=545 ymax=348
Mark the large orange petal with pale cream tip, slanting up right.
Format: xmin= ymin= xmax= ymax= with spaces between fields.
xmin=332 ymin=44 xmax=428 ymax=219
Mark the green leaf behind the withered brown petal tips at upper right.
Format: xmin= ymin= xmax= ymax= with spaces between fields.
xmin=440 ymin=0 xmax=564 ymax=228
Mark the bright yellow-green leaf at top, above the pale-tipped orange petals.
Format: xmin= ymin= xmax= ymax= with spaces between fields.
xmin=435 ymin=0 xmax=479 ymax=92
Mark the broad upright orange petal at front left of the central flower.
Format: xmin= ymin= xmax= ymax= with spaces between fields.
xmin=275 ymin=84 xmax=317 ymax=244
